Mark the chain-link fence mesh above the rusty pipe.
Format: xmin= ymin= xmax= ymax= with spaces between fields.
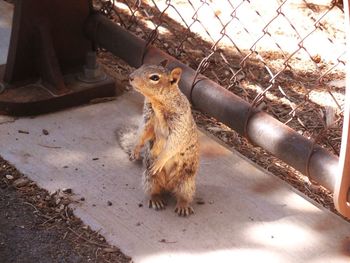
xmin=94 ymin=0 xmax=345 ymax=155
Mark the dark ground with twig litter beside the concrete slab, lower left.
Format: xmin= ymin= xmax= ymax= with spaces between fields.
xmin=0 ymin=157 xmax=132 ymax=263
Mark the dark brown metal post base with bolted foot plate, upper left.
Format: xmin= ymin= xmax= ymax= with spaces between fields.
xmin=0 ymin=0 xmax=115 ymax=115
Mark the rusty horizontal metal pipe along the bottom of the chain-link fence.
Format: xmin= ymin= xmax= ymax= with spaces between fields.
xmin=86 ymin=15 xmax=338 ymax=192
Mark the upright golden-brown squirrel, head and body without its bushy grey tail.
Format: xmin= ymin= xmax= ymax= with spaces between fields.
xmin=130 ymin=61 xmax=199 ymax=216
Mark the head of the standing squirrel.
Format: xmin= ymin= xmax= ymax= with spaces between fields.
xmin=130 ymin=60 xmax=182 ymax=98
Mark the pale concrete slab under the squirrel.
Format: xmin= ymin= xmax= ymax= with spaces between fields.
xmin=0 ymin=93 xmax=350 ymax=263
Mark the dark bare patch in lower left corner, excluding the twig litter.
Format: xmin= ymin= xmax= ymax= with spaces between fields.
xmin=0 ymin=187 xmax=86 ymax=263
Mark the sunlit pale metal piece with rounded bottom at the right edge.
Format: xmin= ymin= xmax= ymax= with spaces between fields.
xmin=334 ymin=1 xmax=350 ymax=218
